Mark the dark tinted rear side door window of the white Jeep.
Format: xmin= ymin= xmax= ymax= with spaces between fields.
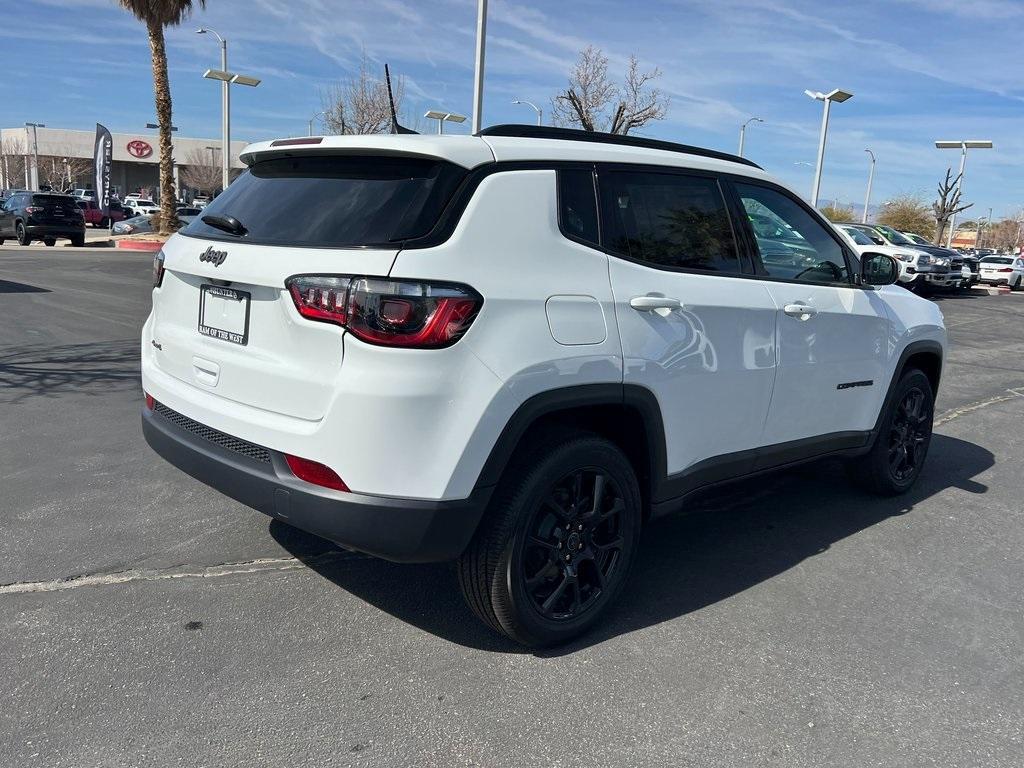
xmin=601 ymin=171 xmax=739 ymax=272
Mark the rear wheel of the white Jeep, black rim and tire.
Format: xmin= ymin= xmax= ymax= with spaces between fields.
xmin=458 ymin=431 xmax=641 ymax=647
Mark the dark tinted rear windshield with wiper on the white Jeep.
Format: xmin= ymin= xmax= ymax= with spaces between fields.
xmin=182 ymin=156 xmax=466 ymax=248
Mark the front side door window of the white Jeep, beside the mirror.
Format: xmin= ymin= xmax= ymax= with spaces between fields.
xmin=735 ymin=183 xmax=849 ymax=283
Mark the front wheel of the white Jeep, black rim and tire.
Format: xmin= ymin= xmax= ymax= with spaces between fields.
xmin=849 ymin=368 xmax=935 ymax=496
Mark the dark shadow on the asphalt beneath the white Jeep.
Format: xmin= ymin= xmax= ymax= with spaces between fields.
xmin=270 ymin=435 xmax=994 ymax=657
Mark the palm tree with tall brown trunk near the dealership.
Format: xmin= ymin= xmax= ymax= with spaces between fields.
xmin=118 ymin=0 xmax=206 ymax=234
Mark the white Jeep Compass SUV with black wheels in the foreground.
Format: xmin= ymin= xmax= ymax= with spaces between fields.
xmin=141 ymin=126 xmax=946 ymax=645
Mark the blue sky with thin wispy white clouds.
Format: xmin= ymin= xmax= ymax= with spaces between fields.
xmin=6 ymin=0 xmax=1024 ymax=217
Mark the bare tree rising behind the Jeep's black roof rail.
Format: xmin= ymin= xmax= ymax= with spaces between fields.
xmin=552 ymin=45 xmax=669 ymax=136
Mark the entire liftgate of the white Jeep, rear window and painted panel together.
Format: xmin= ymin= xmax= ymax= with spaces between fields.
xmin=151 ymin=153 xmax=475 ymax=420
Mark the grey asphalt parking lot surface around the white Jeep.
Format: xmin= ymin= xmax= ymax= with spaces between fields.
xmin=0 ymin=249 xmax=1024 ymax=768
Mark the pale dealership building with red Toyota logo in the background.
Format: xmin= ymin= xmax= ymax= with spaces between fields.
xmin=0 ymin=127 xmax=248 ymax=198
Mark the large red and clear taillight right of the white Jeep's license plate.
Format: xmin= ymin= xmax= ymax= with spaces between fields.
xmin=287 ymin=275 xmax=483 ymax=349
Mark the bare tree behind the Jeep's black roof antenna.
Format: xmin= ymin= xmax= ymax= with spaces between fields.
xmin=321 ymin=53 xmax=404 ymax=135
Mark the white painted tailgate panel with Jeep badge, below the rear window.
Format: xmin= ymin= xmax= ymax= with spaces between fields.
xmin=153 ymin=236 xmax=397 ymax=420
